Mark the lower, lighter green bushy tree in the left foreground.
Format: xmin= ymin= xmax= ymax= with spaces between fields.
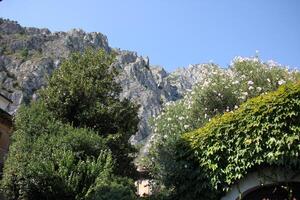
xmin=1 ymin=102 xmax=135 ymax=200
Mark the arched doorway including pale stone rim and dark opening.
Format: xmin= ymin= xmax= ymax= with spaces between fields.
xmin=221 ymin=167 xmax=300 ymax=200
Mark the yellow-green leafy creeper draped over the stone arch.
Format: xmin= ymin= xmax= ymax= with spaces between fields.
xmin=177 ymin=83 xmax=300 ymax=199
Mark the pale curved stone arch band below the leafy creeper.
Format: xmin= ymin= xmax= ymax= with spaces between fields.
xmin=221 ymin=167 xmax=300 ymax=200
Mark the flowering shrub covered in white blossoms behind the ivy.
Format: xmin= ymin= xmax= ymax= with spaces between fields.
xmin=142 ymin=57 xmax=299 ymax=197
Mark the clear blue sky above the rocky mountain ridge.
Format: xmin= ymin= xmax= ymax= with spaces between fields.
xmin=0 ymin=0 xmax=300 ymax=71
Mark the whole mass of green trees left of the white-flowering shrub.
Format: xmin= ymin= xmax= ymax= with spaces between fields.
xmin=1 ymin=50 xmax=138 ymax=200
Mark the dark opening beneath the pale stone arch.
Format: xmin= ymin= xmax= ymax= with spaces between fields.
xmin=241 ymin=182 xmax=300 ymax=200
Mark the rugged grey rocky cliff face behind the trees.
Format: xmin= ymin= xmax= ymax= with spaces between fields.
xmin=0 ymin=19 xmax=213 ymax=143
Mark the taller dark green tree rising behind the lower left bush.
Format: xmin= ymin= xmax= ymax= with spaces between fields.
xmin=40 ymin=49 xmax=139 ymax=176
